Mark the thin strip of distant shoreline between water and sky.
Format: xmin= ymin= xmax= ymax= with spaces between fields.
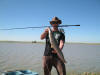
xmin=0 ymin=40 xmax=100 ymax=45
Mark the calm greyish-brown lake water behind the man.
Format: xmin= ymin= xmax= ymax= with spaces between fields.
xmin=0 ymin=43 xmax=100 ymax=75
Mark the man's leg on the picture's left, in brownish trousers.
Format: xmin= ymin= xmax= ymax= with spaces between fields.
xmin=43 ymin=56 xmax=52 ymax=75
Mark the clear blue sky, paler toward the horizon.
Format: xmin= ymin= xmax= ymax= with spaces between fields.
xmin=0 ymin=0 xmax=100 ymax=43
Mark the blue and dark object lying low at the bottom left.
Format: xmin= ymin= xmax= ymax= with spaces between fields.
xmin=2 ymin=70 xmax=39 ymax=75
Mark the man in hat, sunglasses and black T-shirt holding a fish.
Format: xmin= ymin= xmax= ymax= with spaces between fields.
xmin=40 ymin=17 xmax=66 ymax=75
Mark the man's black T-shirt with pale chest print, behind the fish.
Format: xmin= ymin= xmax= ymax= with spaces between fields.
xmin=44 ymin=31 xmax=65 ymax=56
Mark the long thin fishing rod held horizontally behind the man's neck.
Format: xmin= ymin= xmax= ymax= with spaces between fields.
xmin=0 ymin=25 xmax=80 ymax=30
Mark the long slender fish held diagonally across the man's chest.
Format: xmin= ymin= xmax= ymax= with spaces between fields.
xmin=48 ymin=27 xmax=66 ymax=63
